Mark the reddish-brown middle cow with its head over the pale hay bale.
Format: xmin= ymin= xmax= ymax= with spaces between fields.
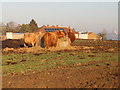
xmin=43 ymin=30 xmax=65 ymax=48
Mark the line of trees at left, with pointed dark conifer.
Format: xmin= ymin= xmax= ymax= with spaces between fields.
xmin=0 ymin=19 xmax=39 ymax=33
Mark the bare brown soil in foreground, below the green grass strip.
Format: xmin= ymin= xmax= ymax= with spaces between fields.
xmin=3 ymin=62 xmax=119 ymax=88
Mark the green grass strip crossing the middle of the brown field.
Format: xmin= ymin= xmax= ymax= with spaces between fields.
xmin=2 ymin=51 xmax=118 ymax=75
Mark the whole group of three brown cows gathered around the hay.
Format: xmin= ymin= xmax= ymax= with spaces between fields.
xmin=23 ymin=30 xmax=76 ymax=48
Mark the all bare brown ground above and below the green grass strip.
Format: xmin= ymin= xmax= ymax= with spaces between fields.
xmin=2 ymin=40 xmax=120 ymax=88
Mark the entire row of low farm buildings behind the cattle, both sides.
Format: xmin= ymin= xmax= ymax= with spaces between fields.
xmin=0 ymin=25 xmax=102 ymax=40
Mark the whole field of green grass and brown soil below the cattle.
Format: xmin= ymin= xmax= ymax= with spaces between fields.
xmin=2 ymin=40 xmax=120 ymax=88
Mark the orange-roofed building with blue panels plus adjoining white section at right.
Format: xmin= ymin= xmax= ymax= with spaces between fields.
xmin=37 ymin=25 xmax=101 ymax=39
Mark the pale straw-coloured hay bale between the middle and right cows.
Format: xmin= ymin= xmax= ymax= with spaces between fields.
xmin=57 ymin=37 xmax=71 ymax=48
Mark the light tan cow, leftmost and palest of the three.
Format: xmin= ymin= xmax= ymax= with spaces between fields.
xmin=23 ymin=32 xmax=41 ymax=47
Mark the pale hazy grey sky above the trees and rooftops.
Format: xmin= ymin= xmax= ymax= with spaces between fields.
xmin=2 ymin=2 xmax=118 ymax=33
